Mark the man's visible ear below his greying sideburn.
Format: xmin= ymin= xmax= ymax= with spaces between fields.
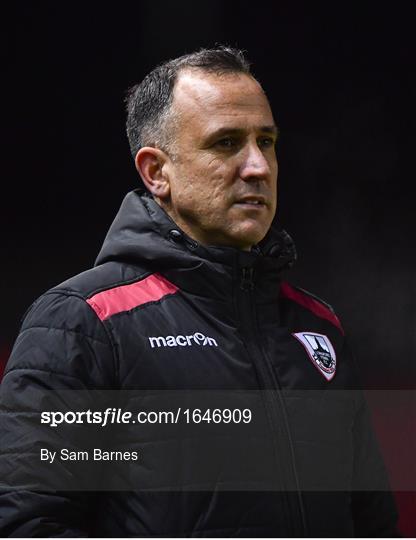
xmin=134 ymin=146 xmax=170 ymax=199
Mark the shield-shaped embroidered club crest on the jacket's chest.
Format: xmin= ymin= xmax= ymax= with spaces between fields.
xmin=292 ymin=332 xmax=337 ymax=381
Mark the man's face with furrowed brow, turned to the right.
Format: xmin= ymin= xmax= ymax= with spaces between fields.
xmin=165 ymin=70 xmax=277 ymax=250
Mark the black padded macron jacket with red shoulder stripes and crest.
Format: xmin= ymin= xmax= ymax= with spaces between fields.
xmin=0 ymin=191 xmax=396 ymax=537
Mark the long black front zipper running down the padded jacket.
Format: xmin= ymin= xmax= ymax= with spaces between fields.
xmin=238 ymin=267 xmax=308 ymax=537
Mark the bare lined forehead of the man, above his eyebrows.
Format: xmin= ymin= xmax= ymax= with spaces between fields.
xmin=172 ymin=70 xmax=274 ymax=131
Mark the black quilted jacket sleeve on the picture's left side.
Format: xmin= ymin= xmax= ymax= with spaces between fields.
xmin=0 ymin=291 xmax=115 ymax=537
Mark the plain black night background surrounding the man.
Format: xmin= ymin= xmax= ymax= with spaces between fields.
xmin=0 ymin=0 xmax=416 ymax=535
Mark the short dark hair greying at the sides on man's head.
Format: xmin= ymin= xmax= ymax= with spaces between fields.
xmin=125 ymin=46 xmax=251 ymax=159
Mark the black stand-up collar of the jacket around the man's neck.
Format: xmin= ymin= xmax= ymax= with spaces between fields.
xmin=95 ymin=189 xmax=296 ymax=297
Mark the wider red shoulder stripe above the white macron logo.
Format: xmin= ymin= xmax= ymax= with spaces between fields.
xmin=87 ymin=274 xmax=178 ymax=321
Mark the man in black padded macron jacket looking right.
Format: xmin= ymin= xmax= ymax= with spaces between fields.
xmin=0 ymin=47 xmax=396 ymax=536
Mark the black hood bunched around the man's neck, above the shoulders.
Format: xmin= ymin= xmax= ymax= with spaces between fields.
xmin=95 ymin=189 xmax=296 ymax=271
